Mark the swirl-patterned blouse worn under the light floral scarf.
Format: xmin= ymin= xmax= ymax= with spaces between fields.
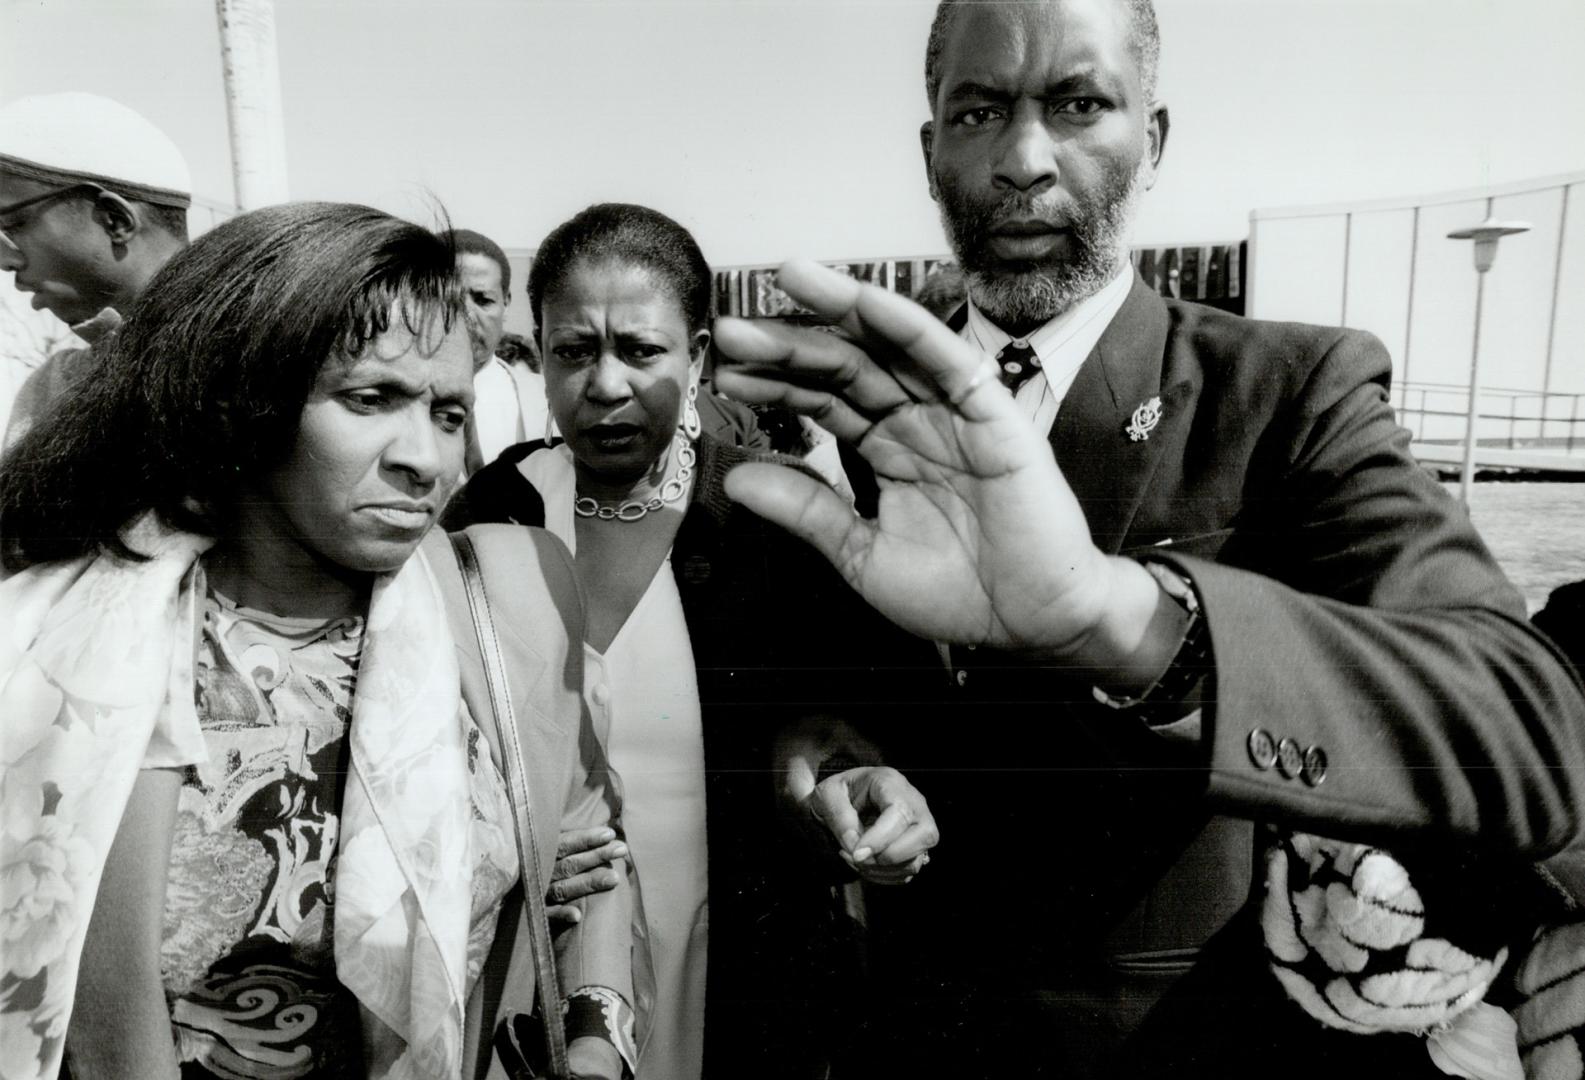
xmin=160 ymin=592 xmax=518 ymax=1078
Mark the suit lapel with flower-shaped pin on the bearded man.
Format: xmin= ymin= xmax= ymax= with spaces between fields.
xmin=1051 ymin=274 xmax=1194 ymax=553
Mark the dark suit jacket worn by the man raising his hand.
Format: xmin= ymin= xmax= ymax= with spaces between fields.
xmin=862 ymin=281 xmax=1585 ymax=1075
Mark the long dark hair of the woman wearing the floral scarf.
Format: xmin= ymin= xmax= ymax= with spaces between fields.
xmin=0 ymin=203 xmax=461 ymax=569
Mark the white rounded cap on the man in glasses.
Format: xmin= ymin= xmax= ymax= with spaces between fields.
xmin=0 ymin=92 xmax=193 ymax=208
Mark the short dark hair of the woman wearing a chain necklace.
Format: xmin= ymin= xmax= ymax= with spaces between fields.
xmin=528 ymin=203 xmax=710 ymax=333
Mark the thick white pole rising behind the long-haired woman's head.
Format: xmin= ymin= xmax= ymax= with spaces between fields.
xmin=216 ymin=0 xmax=287 ymax=209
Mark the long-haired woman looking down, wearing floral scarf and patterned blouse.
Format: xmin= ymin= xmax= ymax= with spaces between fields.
xmin=0 ymin=203 xmax=632 ymax=1080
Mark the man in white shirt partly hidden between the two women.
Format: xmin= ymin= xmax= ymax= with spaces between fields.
xmin=445 ymin=228 xmax=525 ymax=474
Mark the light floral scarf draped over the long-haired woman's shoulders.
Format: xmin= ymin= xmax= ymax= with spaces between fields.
xmin=0 ymin=515 xmax=474 ymax=1080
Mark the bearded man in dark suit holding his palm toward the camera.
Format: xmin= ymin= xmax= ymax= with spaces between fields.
xmin=716 ymin=0 xmax=1585 ymax=1077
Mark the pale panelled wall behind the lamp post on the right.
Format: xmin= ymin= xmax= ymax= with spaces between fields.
xmin=1246 ymin=173 xmax=1585 ymax=466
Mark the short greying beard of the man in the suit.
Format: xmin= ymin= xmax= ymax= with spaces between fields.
xmin=937 ymin=162 xmax=1144 ymax=327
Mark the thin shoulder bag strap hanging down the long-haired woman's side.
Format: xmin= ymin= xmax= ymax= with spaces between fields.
xmin=452 ymin=533 xmax=569 ymax=1080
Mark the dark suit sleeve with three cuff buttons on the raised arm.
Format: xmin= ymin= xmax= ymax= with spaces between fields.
xmin=1162 ymin=331 xmax=1585 ymax=855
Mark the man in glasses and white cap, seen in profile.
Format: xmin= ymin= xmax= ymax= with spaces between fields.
xmin=0 ymin=94 xmax=192 ymax=444
